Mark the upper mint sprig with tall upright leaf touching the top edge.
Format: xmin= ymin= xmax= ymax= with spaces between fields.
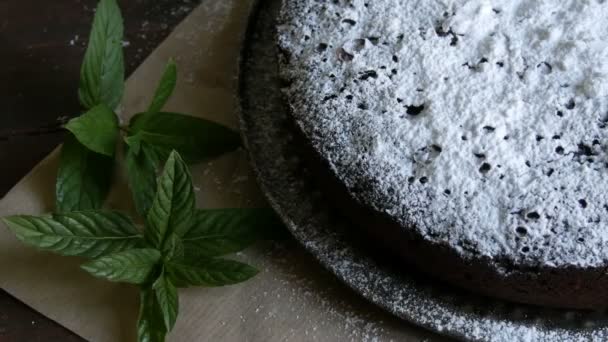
xmin=56 ymin=0 xmax=241 ymax=212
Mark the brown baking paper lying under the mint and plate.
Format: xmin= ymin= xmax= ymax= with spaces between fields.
xmin=0 ymin=0 xmax=437 ymax=342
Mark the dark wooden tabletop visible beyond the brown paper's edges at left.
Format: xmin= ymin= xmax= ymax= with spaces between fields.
xmin=0 ymin=0 xmax=201 ymax=342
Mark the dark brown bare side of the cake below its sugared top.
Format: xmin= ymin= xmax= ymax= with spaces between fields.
xmin=294 ymin=118 xmax=608 ymax=309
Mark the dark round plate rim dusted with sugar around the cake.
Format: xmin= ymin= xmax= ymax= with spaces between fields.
xmin=239 ymin=0 xmax=608 ymax=342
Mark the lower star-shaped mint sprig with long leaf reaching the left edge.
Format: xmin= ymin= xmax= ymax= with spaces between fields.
xmin=3 ymin=151 xmax=280 ymax=341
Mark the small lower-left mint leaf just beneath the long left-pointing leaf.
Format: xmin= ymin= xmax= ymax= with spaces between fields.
xmin=82 ymin=249 xmax=161 ymax=284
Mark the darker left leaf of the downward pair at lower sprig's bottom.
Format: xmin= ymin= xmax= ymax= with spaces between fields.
xmin=137 ymin=289 xmax=167 ymax=342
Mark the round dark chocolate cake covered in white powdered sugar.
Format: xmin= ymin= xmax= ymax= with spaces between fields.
xmin=277 ymin=0 xmax=608 ymax=308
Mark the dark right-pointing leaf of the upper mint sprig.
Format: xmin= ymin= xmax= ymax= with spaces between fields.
xmin=130 ymin=112 xmax=241 ymax=163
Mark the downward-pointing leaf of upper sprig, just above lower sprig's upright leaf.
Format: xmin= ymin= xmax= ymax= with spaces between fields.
xmin=126 ymin=145 xmax=157 ymax=217
